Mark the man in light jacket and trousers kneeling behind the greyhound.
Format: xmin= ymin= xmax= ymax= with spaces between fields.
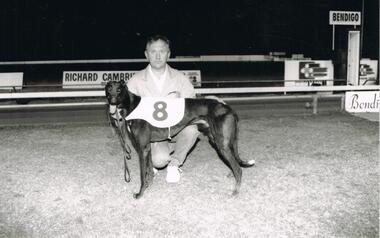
xmin=127 ymin=35 xmax=199 ymax=183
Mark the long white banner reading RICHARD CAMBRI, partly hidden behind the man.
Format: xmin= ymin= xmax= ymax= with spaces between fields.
xmin=62 ymin=70 xmax=201 ymax=89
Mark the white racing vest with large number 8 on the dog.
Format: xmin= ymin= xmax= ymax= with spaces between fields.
xmin=126 ymin=97 xmax=185 ymax=128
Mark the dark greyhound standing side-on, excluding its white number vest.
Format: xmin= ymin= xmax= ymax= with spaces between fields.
xmin=105 ymin=81 xmax=255 ymax=199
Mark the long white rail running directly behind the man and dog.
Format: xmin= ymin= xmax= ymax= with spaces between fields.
xmin=0 ymin=85 xmax=380 ymax=113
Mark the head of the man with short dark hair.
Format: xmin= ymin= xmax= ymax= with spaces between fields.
xmin=145 ymin=40 xmax=170 ymax=69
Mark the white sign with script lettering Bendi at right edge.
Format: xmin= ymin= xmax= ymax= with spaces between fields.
xmin=345 ymin=91 xmax=380 ymax=113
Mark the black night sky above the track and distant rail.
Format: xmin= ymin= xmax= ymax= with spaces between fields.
xmin=0 ymin=0 xmax=379 ymax=61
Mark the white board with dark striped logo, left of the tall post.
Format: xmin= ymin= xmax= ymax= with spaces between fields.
xmin=285 ymin=60 xmax=334 ymax=86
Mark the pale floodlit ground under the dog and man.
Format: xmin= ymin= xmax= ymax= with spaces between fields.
xmin=0 ymin=113 xmax=379 ymax=238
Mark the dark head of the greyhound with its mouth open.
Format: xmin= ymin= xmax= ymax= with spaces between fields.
xmin=105 ymin=80 xmax=128 ymax=114
